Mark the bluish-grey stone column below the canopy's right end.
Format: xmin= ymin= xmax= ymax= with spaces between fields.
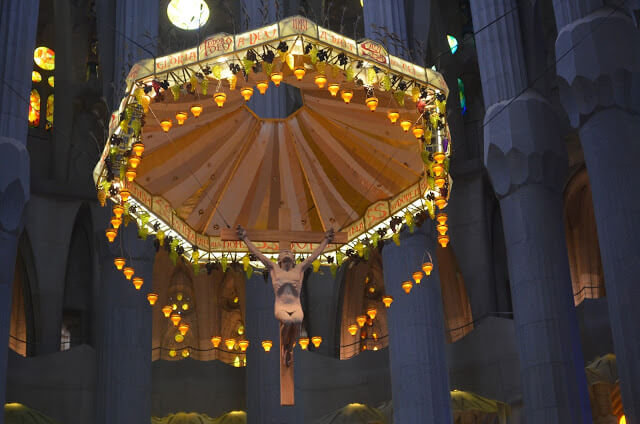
xmin=382 ymin=221 xmax=453 ymax=424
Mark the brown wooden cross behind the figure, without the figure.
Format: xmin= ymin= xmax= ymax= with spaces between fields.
xmin=220 ymin=207 xmax=347 ymax=405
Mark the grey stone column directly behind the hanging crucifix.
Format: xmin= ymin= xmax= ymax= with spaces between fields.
xmin=245 ymin=272 xmax=302 ymax=424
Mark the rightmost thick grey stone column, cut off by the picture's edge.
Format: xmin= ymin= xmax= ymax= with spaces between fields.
xmin=554 ymin=0 xmax=640 ymax=423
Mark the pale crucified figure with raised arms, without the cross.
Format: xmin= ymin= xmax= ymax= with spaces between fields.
xmin=237 ymin=225 xmax=334 ymax=366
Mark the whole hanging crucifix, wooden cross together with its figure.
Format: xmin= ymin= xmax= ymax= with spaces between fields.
xmin=221 ymin=208 xmax=347 ymax=405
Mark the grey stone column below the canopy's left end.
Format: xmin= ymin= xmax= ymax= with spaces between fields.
xmin=94 ymin=217 xmax=156 ymax=424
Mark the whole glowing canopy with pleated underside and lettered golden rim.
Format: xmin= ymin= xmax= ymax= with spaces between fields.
xmin=94 ymin=16 xmax=451 ymax=258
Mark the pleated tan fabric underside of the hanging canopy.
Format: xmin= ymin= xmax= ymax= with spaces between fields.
xmin=136 ymin=78 xmax=423 ymax=236
